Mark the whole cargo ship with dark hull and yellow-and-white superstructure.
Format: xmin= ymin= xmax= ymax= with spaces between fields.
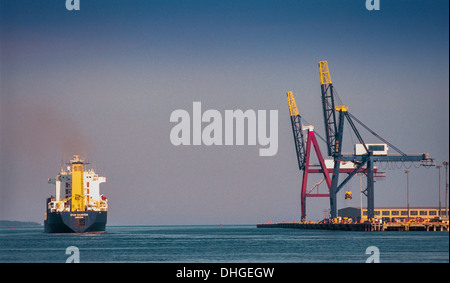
xmin=44 ymin=155 xmax=108 ymax=233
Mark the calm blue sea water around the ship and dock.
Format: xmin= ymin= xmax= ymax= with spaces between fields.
xmin=0 ymin=225 xmax=449 ymax=263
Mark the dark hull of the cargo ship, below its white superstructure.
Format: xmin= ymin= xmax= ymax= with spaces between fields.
xmin=44 ymin=211 xmax=108 ymax=233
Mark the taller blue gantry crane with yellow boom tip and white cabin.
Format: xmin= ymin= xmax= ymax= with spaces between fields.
xmin=319 ymin=61 xmax=434 ymax=219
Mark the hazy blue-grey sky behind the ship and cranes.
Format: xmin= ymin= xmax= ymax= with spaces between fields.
xmin=0 ymin=0 xmax=449 ymax=224
